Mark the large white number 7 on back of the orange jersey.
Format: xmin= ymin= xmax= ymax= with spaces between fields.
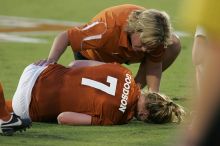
xmin=81 ymin=76 xmax=118 ymax=96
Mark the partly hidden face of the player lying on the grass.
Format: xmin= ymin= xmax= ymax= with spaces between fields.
xmin=136 ymin=95 xmax=149 ymax=121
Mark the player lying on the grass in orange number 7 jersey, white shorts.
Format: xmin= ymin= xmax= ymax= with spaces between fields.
xmin=0 ymin=61 xmax=184 ymax=133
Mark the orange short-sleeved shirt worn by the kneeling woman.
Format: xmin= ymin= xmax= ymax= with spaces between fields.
xmin=68 ymin=4 xmax=164 ymax=64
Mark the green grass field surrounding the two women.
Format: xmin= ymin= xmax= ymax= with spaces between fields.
xmin=0 ymin=0 xmax=194 ymax=146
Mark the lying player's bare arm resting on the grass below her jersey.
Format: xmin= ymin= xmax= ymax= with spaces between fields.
xmin=57 ymin=112 xmax=92 ymax=125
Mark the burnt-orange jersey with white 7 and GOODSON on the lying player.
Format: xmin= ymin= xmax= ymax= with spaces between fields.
xmin=29 ymin=64 xmax=140 ymax=125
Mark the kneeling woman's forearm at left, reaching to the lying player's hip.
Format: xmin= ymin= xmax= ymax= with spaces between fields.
xmin=48 ymin=31 xmax=69 ymax=62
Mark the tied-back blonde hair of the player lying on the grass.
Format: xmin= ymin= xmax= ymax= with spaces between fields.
xmin=145 ymin=93 xmax=185 ymax=124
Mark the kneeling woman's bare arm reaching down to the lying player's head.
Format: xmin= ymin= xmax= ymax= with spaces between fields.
xmin=135 ymin=59 xmax=162 ymax=92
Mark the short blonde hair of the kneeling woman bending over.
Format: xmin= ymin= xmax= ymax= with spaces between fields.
xmin=125 ymin=9 xmax=171 ymax=47
